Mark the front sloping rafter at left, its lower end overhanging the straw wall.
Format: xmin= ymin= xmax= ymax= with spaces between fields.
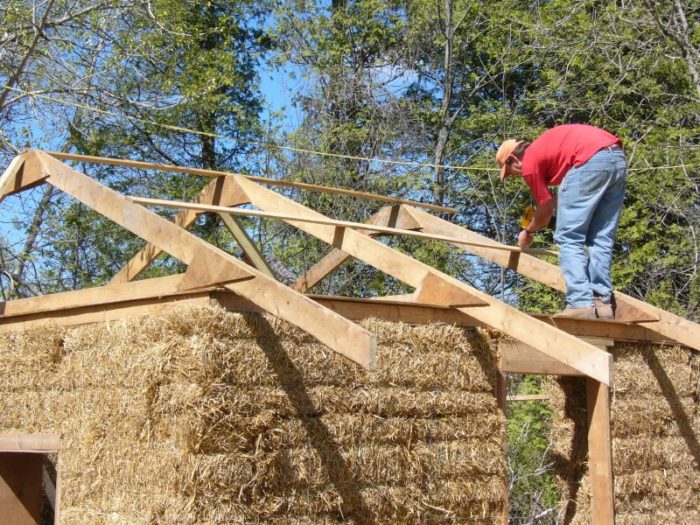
xmin=38 ymin=152 xmax=376 ymax=369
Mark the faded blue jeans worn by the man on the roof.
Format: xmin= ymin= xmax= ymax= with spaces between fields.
xmin=554 ymin=148 xmax=627 ymax=308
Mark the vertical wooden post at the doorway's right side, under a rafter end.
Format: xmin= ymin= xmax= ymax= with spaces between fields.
xmin=586 ymin=378 xmax=615 ymax=525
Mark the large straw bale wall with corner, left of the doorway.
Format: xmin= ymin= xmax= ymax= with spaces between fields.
xmin=0 ymin=307 xmax=505 ymax=524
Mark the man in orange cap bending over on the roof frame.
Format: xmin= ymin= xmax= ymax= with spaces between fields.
xmin=496 ymin=124 xmax=627 ymax=319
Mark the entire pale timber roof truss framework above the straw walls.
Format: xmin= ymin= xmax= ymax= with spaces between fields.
xmin=0 ymin=150 xmax=700 ymax=386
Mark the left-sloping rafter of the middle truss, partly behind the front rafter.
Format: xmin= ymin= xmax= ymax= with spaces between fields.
xmin=111 ymin=177 xmax=246 ymax=284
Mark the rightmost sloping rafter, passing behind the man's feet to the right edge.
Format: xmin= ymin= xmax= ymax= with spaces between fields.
xmin=406 ymin=209 xmax=700 ymax=350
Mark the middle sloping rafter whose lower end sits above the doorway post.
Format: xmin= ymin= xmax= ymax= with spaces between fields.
xmin=231 ymin=177 xmax=612 ymax=384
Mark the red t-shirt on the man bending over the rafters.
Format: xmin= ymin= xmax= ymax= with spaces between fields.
xmin=523 ymin=124 xmax=622 ymax=205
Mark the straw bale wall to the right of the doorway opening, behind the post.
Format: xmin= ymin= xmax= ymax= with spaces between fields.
xmin=551 ymin=344 xmax=700 ymax=525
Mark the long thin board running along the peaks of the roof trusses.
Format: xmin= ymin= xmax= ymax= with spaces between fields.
xmin=47 ymin=151 xmax=459 ymax=214
